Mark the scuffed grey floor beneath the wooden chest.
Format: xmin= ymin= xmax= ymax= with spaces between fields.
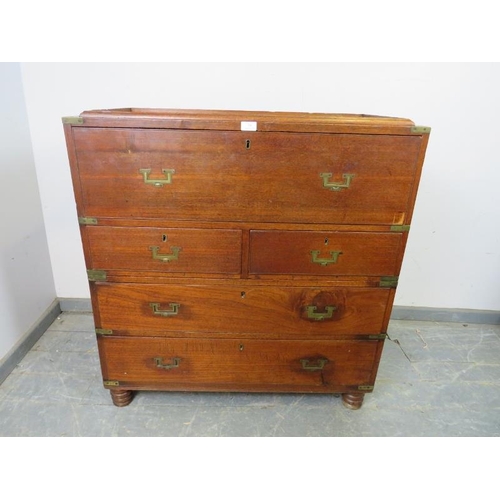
xmin=0 ymin=313 xmax=500 ymax=436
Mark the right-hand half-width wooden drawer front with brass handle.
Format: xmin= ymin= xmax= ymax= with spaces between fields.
xmin=249 ymin=231 xmax=402 ymax=276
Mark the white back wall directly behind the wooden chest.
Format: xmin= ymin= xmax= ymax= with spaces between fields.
xmin=22 ymin=63 xmax=500 ymax=310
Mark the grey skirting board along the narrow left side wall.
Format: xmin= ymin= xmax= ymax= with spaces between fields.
xmin=0 ymin=299 xmax=61 ymax=384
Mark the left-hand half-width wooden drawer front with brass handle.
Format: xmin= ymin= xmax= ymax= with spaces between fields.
xmin=86 ymin=226 xmax=241 ymax=274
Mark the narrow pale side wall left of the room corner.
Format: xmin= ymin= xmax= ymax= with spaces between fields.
xmin=0 ymin=63 xmax=56 ymax=360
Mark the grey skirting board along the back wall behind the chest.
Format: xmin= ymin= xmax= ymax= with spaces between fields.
xmin=59 ymin=299 xmax=500 ymax=325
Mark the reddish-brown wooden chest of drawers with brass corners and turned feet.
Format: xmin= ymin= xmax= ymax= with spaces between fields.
xmin=63 ymin=109 xmax=429 ymax=409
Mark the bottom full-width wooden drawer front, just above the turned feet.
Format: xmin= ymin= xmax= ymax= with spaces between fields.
xmin=99 ymin=337 xmax=379 ymax=392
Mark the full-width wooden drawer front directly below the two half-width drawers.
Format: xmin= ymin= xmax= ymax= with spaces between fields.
xmin=95 ymin=284 xmax=392 ymax=339
